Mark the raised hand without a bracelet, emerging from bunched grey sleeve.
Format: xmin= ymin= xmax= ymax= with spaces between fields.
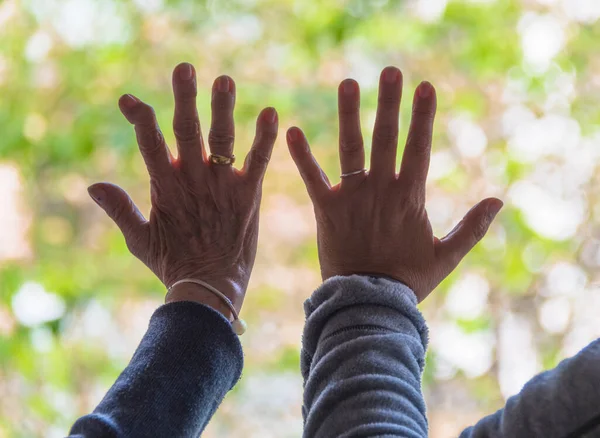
xmin=287 ymin=67 xmax=502 ymax=302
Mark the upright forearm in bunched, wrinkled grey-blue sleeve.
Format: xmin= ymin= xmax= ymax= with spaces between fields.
xmin=302 ymin=276 xmax=427 ymax=438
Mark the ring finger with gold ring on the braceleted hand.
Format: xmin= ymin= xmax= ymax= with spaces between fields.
xmin=208 ymin=76 xmax=235 ymax=166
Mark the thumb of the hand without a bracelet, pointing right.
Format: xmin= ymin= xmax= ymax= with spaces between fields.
xmin=436 ymin=198 xmax=504 ymax=272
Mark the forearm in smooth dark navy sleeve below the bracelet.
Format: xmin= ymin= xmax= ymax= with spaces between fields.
xmin=70 ymin=302 xmax=243 ymax=438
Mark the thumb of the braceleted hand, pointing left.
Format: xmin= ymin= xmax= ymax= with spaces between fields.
xmin=88 ymin=183 xmax=147 ymax=252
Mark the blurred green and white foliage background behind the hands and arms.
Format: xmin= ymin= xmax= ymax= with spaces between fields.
xmin=0 ymin=0 xmax=600 ymax=438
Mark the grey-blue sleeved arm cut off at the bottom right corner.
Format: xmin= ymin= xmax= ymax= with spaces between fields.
xmin=460 ymin=340 xmax=600 ymax=438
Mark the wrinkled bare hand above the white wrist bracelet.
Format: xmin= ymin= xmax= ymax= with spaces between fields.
xmin=89 ymin=63 xmax=278 ymax=313
